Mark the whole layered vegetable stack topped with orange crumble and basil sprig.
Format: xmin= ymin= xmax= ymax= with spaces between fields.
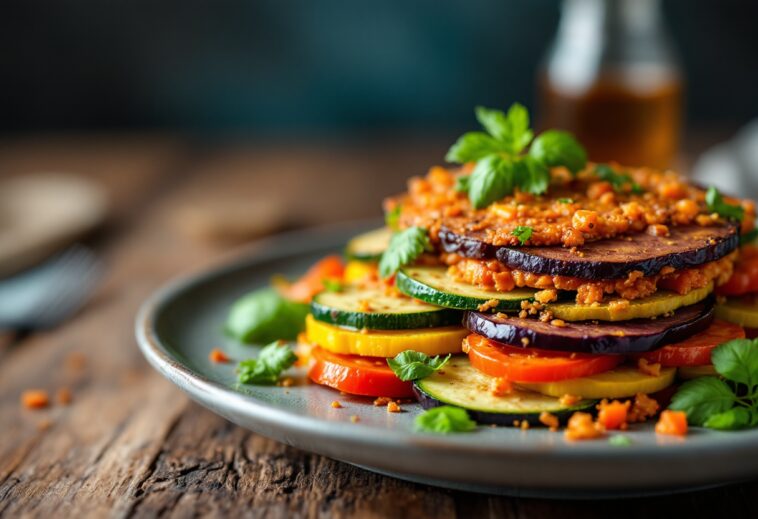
xmin=296 ymin=105 xmax=758 ymax=432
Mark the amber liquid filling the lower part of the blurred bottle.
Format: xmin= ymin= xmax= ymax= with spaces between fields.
xmin=540 ymin=70 xmax=682 ymax=168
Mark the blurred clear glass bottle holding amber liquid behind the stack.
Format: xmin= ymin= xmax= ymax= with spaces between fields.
xmin=538 ymin=0 xmax=683 ymax=168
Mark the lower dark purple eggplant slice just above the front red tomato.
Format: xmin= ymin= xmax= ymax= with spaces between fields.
xmin=463 ymin=297 xmax=714 ymax=354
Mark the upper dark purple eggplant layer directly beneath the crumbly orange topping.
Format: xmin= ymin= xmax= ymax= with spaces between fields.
xmin=439 ymin=222 xmax=739 ymax=279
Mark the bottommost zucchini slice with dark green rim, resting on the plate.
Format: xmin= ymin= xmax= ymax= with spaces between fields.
xmin=414 ymin=356 xmax=597 ymax=425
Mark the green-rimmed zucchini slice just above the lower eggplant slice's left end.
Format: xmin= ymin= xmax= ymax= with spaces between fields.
xmin=395 ymin=267 xmax=536 ymax=312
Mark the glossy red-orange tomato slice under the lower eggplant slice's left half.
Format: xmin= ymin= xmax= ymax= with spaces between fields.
xmin=464 ymin=334 xmax=624 ymax=382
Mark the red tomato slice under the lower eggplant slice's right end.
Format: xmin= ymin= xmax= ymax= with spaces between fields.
xmin=639 ymin=319 xmax=745 ymax=367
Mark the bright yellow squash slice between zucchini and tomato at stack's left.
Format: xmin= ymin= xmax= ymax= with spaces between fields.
xmin=305 ymin=315 xmax=469 ymax=357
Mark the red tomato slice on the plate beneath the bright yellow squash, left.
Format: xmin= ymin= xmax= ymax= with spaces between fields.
xmin=308 ymin=347 xmax=413 ymax=398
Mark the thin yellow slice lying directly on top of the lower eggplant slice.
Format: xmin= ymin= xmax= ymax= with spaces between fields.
xmin=547 ymin=283 xmax=713 ymax=321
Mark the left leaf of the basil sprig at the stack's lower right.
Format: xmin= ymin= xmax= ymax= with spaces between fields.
xmin=669 ymin=377 xmax=736 ymax=425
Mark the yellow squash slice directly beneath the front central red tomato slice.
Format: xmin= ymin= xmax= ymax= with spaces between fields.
xmin=519 ymin=366 xmax=676 ymax=398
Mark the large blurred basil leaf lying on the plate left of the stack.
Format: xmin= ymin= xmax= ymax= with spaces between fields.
xmin=225 ymin=288 xmax=308 ymax=343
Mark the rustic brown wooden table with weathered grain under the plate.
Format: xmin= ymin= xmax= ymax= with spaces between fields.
xmin=0 ymin=137 xmax=758 ymax=519
